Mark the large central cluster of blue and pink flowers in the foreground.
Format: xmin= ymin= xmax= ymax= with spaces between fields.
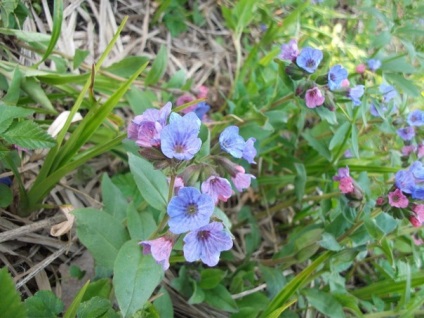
xmin=128 ymin=98 xmax=257 ymax=270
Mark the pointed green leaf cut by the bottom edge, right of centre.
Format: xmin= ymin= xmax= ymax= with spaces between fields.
xmin=303 ymin=289 xmax=345 ymax=318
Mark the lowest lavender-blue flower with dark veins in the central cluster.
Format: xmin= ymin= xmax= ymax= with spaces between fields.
xmin=183 ymin=222 xmax=233 ymax=266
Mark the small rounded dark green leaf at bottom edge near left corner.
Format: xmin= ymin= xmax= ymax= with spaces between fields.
xmin=25 ymin=290 xmax=64 ymax=318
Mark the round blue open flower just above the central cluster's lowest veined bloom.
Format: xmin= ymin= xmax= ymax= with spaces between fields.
xmin=167 ymin=187 xmax=215 ymax=234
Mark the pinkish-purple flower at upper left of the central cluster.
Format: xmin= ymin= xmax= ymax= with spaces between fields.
xmin=127 ymin=102 xmax=172 ymax=148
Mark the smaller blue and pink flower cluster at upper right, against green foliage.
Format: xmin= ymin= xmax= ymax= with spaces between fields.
xmin=278 ymin=39 xmax=364 ymax=111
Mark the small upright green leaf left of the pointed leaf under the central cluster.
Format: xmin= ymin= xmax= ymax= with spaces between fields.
xmin=101 ymin=173 xmax=128 ymax=223
